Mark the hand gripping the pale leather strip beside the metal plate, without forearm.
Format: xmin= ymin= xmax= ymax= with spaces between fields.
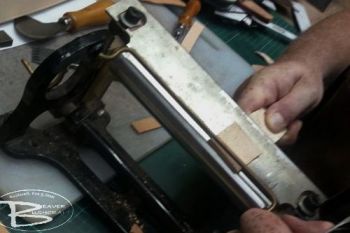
xmin=235 ymin=61 xmax=323 ymax=144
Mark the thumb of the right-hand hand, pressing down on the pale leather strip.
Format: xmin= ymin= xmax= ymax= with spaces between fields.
xmin=266 ymin=78 xmax=322 ymax=132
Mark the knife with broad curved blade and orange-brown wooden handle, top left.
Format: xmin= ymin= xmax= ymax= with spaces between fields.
xmin=15 ymin=0 xmax=114 ymax=40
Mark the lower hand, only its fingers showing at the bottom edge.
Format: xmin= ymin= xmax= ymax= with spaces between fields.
xmin=239 ymin=209 xmax=333 ymax=233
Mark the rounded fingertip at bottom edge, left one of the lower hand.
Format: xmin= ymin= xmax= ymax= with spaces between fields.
xmin=241 ymin=209 xmax=292 ymax=233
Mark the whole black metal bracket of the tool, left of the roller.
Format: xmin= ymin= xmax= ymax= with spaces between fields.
xmin=0 ymin=27 xmax=193 ymax=233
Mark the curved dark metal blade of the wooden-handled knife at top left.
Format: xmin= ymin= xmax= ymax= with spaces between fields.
xmin=15 ymin=16 xmax=67 ymax=40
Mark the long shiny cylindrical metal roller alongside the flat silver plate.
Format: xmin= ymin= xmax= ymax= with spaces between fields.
xmin=111 ymin=53 xmax=271 ymax=208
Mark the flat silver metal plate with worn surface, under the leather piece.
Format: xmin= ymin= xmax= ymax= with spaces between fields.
xmin=108 ymin=0 xmax=323 ymax=208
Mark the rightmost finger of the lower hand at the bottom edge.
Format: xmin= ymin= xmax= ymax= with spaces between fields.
xmin=281 ymin=215 xmax=333 ymax=233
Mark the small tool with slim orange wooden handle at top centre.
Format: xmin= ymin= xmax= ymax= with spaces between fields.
xmin=174 ymin=0 xmax=201 ymax=41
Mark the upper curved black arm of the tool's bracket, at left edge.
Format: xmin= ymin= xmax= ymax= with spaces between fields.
xmin=0 ymin=30 xmax=107 ymax=144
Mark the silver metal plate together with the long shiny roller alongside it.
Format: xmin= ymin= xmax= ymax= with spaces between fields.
xmin=107 ymin=0 xmax=324 ymax=211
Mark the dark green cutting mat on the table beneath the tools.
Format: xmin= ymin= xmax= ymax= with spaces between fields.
xmin=0 ymin=8 xmax=295 ymax=233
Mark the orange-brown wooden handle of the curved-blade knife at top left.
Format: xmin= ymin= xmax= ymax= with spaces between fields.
xmin=63 ymin=0 xmax=114 ymax=32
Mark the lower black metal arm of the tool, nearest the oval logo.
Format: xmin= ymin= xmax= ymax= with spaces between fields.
xmin=4 ymin=125 xmax=138 ymax=233
